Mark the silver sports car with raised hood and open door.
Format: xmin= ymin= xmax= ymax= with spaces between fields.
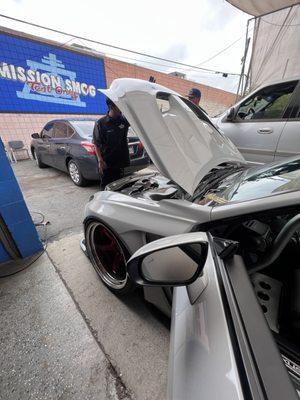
xmin=84 ymin=79 xmax=300 ymax=400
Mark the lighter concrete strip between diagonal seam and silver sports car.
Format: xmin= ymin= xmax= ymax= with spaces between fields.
xmin=47 ymin=234 xmax=169 ymax=400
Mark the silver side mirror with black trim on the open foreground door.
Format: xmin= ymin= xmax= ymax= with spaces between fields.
xmin=127 ymin=232 xmax=208 ymax=286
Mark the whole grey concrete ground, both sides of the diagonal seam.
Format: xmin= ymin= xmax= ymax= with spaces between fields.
xmin=0 ymin=161 xmax=169 ymax=400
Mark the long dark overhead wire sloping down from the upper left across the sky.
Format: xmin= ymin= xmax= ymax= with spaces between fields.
xmin=0 ymin=14 xmax=239 ymax=76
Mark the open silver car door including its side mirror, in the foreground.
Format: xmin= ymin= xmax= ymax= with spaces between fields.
xmin=127 ymin=232 xmax=298 ymax=400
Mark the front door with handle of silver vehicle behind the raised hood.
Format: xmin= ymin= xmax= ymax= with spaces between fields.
xmin=218 ymin=80 xmax=298 ymax=163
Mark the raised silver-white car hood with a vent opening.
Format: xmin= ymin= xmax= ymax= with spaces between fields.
xmin=100 ymin=78 xmax=245 ymax=195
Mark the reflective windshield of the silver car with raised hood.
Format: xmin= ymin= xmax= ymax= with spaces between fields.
xmin=204 ymin=159 xmax=300 ymax=205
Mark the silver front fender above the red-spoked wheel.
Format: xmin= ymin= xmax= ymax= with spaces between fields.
xmin=85 ymin=191 xmax=211 ymax=253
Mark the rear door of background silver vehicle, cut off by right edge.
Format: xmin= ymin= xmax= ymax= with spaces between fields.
xmin=275 ymin=83 xmax=300 ymax=160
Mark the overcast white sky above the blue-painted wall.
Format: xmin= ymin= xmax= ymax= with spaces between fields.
xmin=0 ymin=0 xmax=250 ymax=91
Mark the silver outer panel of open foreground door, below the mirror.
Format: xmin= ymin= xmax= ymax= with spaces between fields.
xmin=167 ymin=239 xmax=243 ymax=400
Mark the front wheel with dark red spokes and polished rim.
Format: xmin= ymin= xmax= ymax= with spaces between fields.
xmin=86 ymin=221 xmax=134 ymax=295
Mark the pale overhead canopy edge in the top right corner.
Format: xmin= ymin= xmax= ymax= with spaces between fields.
xmin=227 ymin=0 xmax=300 ymax=17
